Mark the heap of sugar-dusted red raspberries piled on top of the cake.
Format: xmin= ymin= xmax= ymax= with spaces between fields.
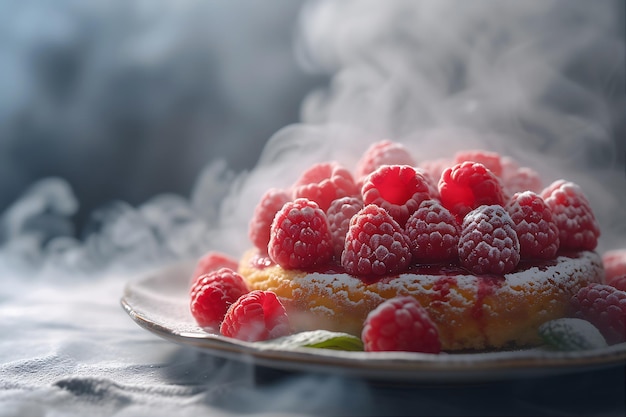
xmin=250 ymin=140 xmax=600 ymax=277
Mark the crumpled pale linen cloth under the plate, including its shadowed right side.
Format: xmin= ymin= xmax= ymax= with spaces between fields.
xmin=0 ymin=262 xmax=626 ymax=417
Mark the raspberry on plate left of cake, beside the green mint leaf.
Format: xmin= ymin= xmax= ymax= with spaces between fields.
xmin=220 ymin=290 xmax=291 ymax=342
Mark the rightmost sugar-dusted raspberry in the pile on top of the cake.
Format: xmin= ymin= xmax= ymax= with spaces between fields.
xmin=541 ymin=180 xmax=600 ymax=250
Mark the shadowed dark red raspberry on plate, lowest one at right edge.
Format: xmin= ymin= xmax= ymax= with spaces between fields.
xmin=570 ymin=283 xmax=626 ymax=344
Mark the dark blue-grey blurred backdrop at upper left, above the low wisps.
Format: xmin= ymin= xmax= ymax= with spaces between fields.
xmin=0 ymin=0 xmax=324 ymax=234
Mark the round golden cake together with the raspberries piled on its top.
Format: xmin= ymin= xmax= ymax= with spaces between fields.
xmin=192 ymin=141 xmax=604 ymax=352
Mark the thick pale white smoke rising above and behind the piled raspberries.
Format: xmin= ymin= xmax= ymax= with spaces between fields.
xmin=288 ymin=0 xmax=626 ymax=249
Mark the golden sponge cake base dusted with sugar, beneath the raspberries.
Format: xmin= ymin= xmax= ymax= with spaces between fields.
xmin=242 ymin=247 xmax=604 ymax=350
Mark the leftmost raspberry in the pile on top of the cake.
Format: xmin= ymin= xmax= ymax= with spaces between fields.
xmin=248 ymin=188 xmax=291 ymax=252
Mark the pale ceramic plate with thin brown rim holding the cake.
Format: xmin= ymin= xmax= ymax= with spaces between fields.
xmin=121 ymin=265 xmax=626 ymax=383
